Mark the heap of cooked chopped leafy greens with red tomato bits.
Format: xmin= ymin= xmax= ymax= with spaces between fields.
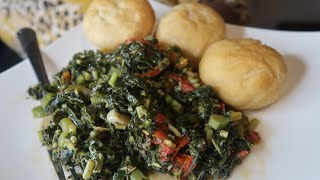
xmin=29 ymin=39 xmax=260 ymax=179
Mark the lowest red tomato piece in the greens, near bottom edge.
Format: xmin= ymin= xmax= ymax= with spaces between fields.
xmin=175 ymin=154 xmax=196 ymax=177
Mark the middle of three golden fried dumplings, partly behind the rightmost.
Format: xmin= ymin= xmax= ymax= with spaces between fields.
xmin=156 ymin=3 xmax=225 ymax=69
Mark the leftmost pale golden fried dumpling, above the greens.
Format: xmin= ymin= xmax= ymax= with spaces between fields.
xmin=83 ymin=0 xmax=155 ymax=52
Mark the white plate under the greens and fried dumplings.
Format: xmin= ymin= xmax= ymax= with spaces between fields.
xmin=0 ymin=2 xmax=320 ymax=180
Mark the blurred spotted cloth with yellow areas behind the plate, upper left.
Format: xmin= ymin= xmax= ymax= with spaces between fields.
xmin=0 ymin=0 xmax=91 ymax=54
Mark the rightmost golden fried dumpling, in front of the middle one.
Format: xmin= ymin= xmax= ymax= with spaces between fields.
xmin=199 ymin=39 xmax=287 ymax=110
